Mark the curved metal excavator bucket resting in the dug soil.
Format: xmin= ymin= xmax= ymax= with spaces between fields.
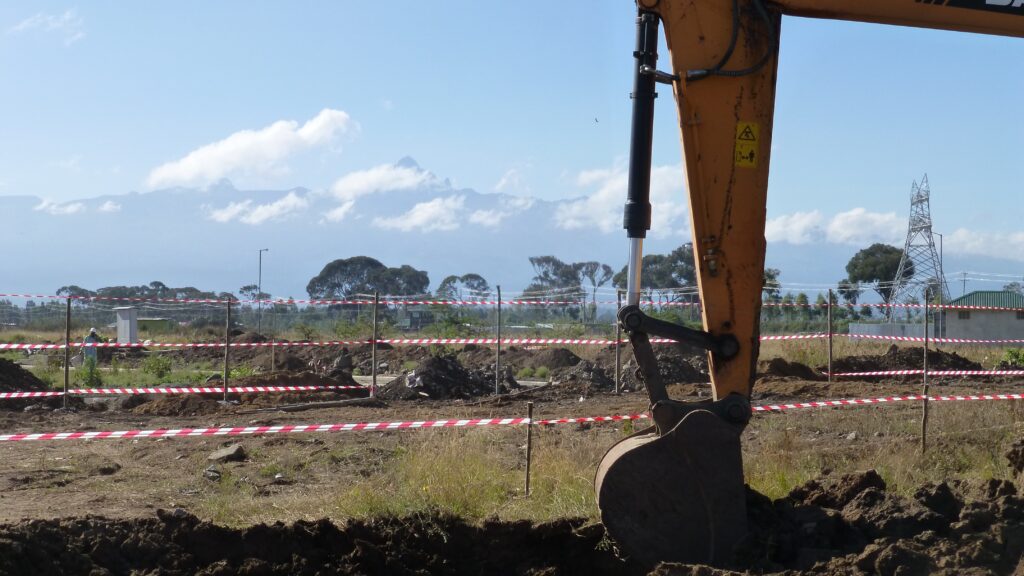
xmin=595 ymin=410 xmax=746 ymax=566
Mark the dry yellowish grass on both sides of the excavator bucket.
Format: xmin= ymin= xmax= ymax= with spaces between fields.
xmin=186 ymin=402 xmax=1024 ymax=526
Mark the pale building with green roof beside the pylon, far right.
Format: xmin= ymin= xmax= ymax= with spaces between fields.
xmin=943 ymin=290 xmax=1024 ymax=340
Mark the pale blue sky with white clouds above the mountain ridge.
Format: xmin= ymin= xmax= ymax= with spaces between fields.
xmin=0 ymin=0 xmax=1024 ymax=291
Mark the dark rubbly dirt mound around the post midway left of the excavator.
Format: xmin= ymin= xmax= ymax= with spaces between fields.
xmin=379 ymin=356 xmax=509 ymax=400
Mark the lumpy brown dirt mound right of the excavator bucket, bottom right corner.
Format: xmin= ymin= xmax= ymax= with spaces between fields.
xmin=708 ymin=470 xmax=1024 ymax=575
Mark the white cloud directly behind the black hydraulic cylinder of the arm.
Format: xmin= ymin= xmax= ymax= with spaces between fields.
xmin=554 ymin=158 xmax=689 ymax=238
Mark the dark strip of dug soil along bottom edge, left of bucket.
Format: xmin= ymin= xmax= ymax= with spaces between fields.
xmin=0 ymin=510 xmax=627 ymax=576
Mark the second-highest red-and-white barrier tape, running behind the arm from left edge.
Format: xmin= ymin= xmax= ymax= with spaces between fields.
xmin=0 ymin=334 xmax=828 ymax=349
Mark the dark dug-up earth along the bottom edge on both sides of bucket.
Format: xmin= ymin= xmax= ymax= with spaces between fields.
xmin=0 ymin=463 xmax=1024 ymax=576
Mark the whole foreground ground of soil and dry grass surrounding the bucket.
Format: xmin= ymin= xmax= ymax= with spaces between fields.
xmin=0 ymin=342 xmax=1024 ymax=574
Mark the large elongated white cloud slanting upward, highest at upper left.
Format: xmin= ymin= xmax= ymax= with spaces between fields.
xmin=146 ymin=109 xmax=352 ymax=189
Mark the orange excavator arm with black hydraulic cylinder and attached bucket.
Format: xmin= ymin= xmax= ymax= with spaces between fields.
xmin=596 ymin=0 xmax=1024 ymax=564
